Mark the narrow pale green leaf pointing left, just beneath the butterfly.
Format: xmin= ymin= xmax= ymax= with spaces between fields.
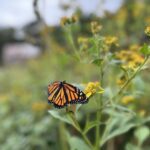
xmin=48 ymin=110 xmax=74 ymax=125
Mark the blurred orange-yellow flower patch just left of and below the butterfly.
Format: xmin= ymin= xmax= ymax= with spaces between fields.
xmin=32 ymin=102 xmax=47 ymax=112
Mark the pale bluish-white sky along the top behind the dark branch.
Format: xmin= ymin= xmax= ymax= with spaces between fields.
xmin=0 ymin=0 xmax=123 ymax=28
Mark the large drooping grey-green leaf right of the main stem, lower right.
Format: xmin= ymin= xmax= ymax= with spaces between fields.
xmin=100 ymin=107 xmax=150 ymax=146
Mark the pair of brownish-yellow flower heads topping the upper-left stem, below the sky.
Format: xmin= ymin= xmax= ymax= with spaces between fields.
xmin=60 ymin=15 xmax=78 ymax=26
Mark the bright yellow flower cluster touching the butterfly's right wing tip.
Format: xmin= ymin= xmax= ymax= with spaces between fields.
xmin=84 ymin=82 xmax=104 ymax=97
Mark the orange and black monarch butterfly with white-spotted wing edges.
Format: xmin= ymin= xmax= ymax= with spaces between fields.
xmin=48 ymin=81 xmax=88 ymax=108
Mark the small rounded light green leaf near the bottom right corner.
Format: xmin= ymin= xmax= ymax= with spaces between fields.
xmin=134 ymin=126 xmax=150 ymax=145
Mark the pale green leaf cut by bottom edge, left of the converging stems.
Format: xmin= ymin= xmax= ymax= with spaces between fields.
xmin=68 ymin=136 xmax=90 ymax=150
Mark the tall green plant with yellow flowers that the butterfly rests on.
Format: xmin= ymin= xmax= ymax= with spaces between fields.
xmin=49 ymin=18 xmax=150 ymax=150
